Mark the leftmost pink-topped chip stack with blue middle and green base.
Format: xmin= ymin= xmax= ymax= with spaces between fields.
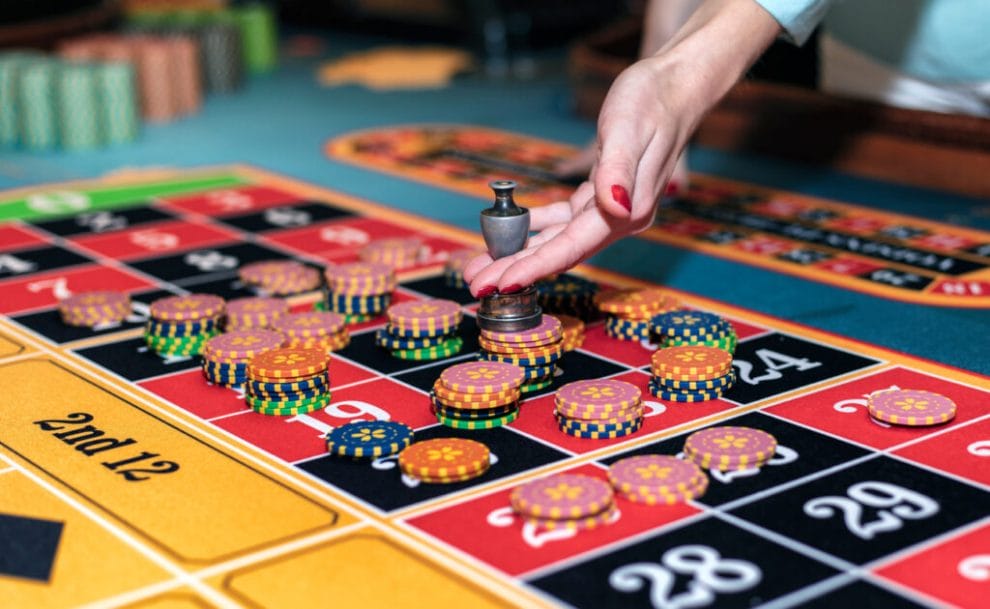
xmin=144 ymin=294 xmax=226 ymax=356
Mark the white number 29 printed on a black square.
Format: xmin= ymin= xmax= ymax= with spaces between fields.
xmin=804 ymin=481 xmax=939 ymax=539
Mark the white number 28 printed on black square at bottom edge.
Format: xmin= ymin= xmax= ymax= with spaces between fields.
xmin=608 ymin=544 xmax=763 ymax=609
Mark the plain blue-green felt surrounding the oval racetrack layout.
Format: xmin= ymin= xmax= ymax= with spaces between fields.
xmin=0 ymin=35 xmax=990 ymax=373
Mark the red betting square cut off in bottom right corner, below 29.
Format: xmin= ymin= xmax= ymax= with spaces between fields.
xmin=875 ymin=524 xmax=990 ymax=609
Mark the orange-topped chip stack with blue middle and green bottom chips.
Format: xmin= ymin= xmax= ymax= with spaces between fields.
xmin=244 ymin=347 xmax=330 ymax=416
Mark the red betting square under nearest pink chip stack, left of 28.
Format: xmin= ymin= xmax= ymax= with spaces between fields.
xmin=407 ymin=465 xmax=698 ymax=575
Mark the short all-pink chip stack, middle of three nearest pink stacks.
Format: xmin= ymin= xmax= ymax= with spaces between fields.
xmin=608 ymin=455 xmax=708 ymax=505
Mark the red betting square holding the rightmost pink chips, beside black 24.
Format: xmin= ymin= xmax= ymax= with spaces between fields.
xmin=767 ymin=368 xmax=990 ymax=449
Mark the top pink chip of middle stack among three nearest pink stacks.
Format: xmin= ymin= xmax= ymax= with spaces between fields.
xmin=608 ymin=455 xmax=705 ymax=494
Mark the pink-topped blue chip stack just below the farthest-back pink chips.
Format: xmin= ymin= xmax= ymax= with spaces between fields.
xmin=324 ymin=262 xmax=396 ymax=323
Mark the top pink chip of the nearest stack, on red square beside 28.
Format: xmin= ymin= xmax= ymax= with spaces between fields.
xmin=509 ymin=474 xmax=615 ymax=519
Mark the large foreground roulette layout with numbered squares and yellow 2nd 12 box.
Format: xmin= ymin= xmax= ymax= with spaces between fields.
xmin=0 ymin=168 xmax=990 ymax=607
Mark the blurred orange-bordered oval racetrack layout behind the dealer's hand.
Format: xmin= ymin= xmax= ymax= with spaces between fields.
xmin=326 ymin=125 xmax=990 ymax=308
